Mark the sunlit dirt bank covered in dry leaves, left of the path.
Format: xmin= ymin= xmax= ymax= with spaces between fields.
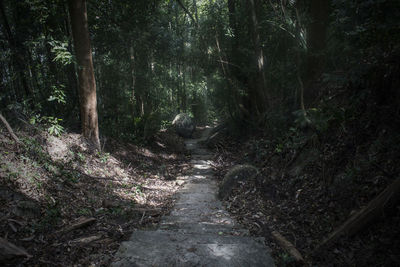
xmin=0 ymin=127 xmax=188 ymax=266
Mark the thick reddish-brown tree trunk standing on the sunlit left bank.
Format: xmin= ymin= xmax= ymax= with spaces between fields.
xmin=68 ymin=0 xmax=100 ymax=149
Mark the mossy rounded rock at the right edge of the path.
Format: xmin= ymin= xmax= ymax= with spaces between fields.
xmin=218 ymin=165 xmax=259 ymax=199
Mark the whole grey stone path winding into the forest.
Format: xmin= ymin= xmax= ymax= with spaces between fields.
xmin=112 ymin=130 xmax=274 ymax=267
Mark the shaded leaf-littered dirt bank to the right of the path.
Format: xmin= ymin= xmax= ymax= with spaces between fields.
xmin=214 ymin=134 xmax=400 ymax=266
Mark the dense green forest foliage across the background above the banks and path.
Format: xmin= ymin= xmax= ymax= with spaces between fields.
xmin=0 ymin=0 xmax=400 ymax=149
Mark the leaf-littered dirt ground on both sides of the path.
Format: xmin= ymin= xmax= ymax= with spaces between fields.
xmin=0 ymin=122 xmax=400 ymax=266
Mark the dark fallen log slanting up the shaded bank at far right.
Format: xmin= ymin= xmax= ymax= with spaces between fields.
xmin=314 ymin=178 xmax=400 ymax=252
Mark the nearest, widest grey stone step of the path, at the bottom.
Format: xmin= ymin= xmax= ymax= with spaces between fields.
xmin=112 ymin=230 xmax=274 ymax=267
